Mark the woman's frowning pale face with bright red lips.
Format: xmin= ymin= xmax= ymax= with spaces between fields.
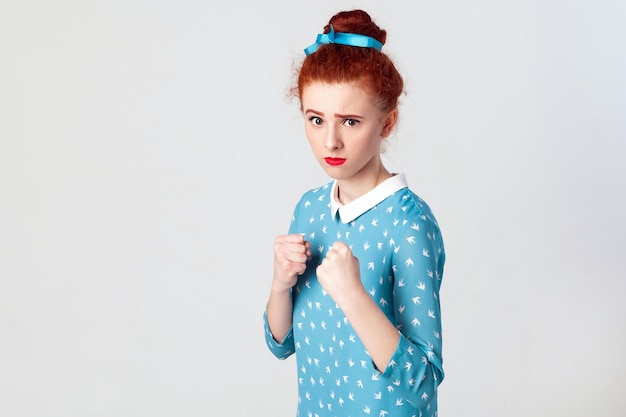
xmin=301 ymin=82 xmax=397 ymax=182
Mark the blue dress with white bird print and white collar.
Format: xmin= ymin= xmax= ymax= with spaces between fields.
xmin=265 ymin=174 xmax=445 ymax=417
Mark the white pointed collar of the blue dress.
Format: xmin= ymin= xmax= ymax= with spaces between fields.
xmin=330 ymin=174 xmax=409 ymax=223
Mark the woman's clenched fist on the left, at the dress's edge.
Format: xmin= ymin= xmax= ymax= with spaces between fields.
xmin=272 ymin=234 xmax=311 ymax=290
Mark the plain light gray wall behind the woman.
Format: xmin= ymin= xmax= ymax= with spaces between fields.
xmin=0 ymin=0 xmax=626 ymax=417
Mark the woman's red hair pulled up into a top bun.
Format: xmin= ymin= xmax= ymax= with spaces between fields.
xmin=294 ymin=10 xmax=404 ymax=111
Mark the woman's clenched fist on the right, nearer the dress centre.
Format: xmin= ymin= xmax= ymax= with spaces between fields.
xmin=317 ymin=241 xmax=365 ymax=307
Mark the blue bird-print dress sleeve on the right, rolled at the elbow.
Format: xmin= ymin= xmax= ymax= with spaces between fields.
xmin=381 ymin=197 xmax=445 ymax=408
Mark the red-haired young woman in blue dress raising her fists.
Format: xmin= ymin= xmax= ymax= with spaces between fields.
xmin=264 ymin=10 xmax=445 ymax=417
